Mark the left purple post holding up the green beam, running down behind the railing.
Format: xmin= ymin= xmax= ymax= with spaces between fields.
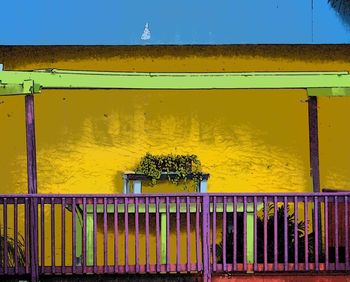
xmin=25 ymin=93 xmax=39 ymax=281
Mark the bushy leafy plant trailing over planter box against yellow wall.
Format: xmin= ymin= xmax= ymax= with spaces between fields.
xmin=135 ymin=153 xmax=201 ymax=187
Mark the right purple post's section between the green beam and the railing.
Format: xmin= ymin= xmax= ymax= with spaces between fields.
xmin=308 ymin=96 xmax=320 ymax=192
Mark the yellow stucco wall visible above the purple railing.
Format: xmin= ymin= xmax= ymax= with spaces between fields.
xmin=0 ymin=45 xmax=350 ymax=196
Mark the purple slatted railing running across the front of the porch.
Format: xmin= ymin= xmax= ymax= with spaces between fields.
xmin=0 ymin=192 xmax=350 ymax=277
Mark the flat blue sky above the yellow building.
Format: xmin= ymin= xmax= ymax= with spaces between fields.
xmin=0 ymin=0 xmax=350 ymax=45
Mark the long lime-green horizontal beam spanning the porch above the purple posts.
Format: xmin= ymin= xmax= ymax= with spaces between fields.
xmin=0 ymin=70 xmax=350 ymax=96
